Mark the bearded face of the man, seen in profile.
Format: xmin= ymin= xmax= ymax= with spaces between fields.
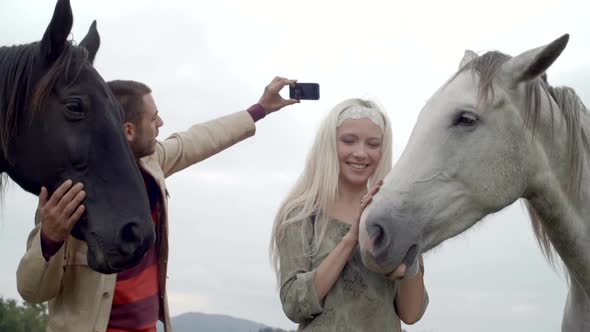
xmin=128 ymin=94 xmax=164 ymax=159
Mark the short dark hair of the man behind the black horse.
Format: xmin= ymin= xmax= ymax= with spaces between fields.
xmin=107 ymin=80 xmax=152 ymax=125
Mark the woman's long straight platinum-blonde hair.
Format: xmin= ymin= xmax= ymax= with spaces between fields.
xmin=270 ymin=98 xmax=393 ymax=284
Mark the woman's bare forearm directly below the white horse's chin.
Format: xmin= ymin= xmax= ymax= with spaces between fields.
xmin=395 ymin=272 xmax=426 ymax=324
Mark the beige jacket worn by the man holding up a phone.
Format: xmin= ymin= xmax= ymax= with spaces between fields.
xmin=17 ymin=111 xmax=256 ymax=332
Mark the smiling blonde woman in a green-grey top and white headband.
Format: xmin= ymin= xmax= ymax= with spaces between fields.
xmin=271 ymin=99 xmax=428 ymax=332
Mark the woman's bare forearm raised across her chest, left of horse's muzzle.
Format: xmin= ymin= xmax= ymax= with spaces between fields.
xmin=314 ymin=238 xmax=356 ymax=301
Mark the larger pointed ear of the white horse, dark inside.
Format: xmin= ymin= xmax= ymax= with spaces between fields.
xmin=502 ymin=34 xmax=569 ymax=86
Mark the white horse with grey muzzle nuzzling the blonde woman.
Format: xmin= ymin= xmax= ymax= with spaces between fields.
xmin=360 ymin=35 xmax=590 ymax=332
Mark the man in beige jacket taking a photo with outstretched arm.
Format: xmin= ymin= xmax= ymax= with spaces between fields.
xmin=17 ymin=77 xmax=298 ymax=332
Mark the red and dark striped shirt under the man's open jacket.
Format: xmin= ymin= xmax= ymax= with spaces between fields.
xmin=106 ymin=172 xmax=160 ymax=332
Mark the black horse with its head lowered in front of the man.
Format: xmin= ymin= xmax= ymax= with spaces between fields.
xmin=0 ymin=0 xmax=155 ymax=273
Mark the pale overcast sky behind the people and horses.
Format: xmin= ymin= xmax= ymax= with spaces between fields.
xmin=0 ymin=0 xmax=590 ymax=332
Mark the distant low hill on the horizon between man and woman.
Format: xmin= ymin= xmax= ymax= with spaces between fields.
xmin=158 ymin=312 xmax=294 ymax=332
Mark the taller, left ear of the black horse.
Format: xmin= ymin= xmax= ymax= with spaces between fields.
xmin=41 ymin=0 xmax=74 ymax=62
